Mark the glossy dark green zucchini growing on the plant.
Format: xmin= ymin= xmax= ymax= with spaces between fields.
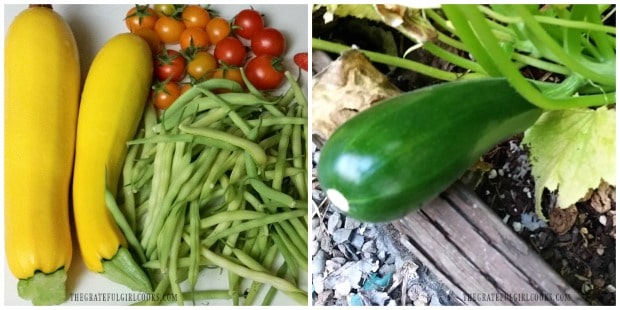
xmin=318 ymin=78 xmax=542 ymax=222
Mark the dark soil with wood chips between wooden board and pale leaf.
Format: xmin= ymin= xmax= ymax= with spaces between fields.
xmin=476 ymin=137 xmax=616 ymax=305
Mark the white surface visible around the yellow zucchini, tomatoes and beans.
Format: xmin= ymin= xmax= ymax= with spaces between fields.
xmin=2 ymin=4 xmax=309 ymax=306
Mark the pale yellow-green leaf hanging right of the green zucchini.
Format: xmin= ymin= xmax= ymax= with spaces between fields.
xmin=523 ymin=107 xmax=616 ymax=218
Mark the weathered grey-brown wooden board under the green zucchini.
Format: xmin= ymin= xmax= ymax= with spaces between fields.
xmin=393 ymin=184 xmax=586 ymax=305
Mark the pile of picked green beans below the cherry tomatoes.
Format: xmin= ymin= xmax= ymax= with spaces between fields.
xmin=114 ymin=72 xmax=308 ymax=305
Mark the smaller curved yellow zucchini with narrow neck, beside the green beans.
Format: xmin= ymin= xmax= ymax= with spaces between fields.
xmin=73 ymin=33 xmax=153 ymax=291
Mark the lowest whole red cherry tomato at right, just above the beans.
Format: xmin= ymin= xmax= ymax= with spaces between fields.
xmin=245 ymin=55 xmax=284 ymax=90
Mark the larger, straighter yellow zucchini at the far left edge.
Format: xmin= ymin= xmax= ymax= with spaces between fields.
xmin=4 ymin=6 xmax=80 ymax=305
